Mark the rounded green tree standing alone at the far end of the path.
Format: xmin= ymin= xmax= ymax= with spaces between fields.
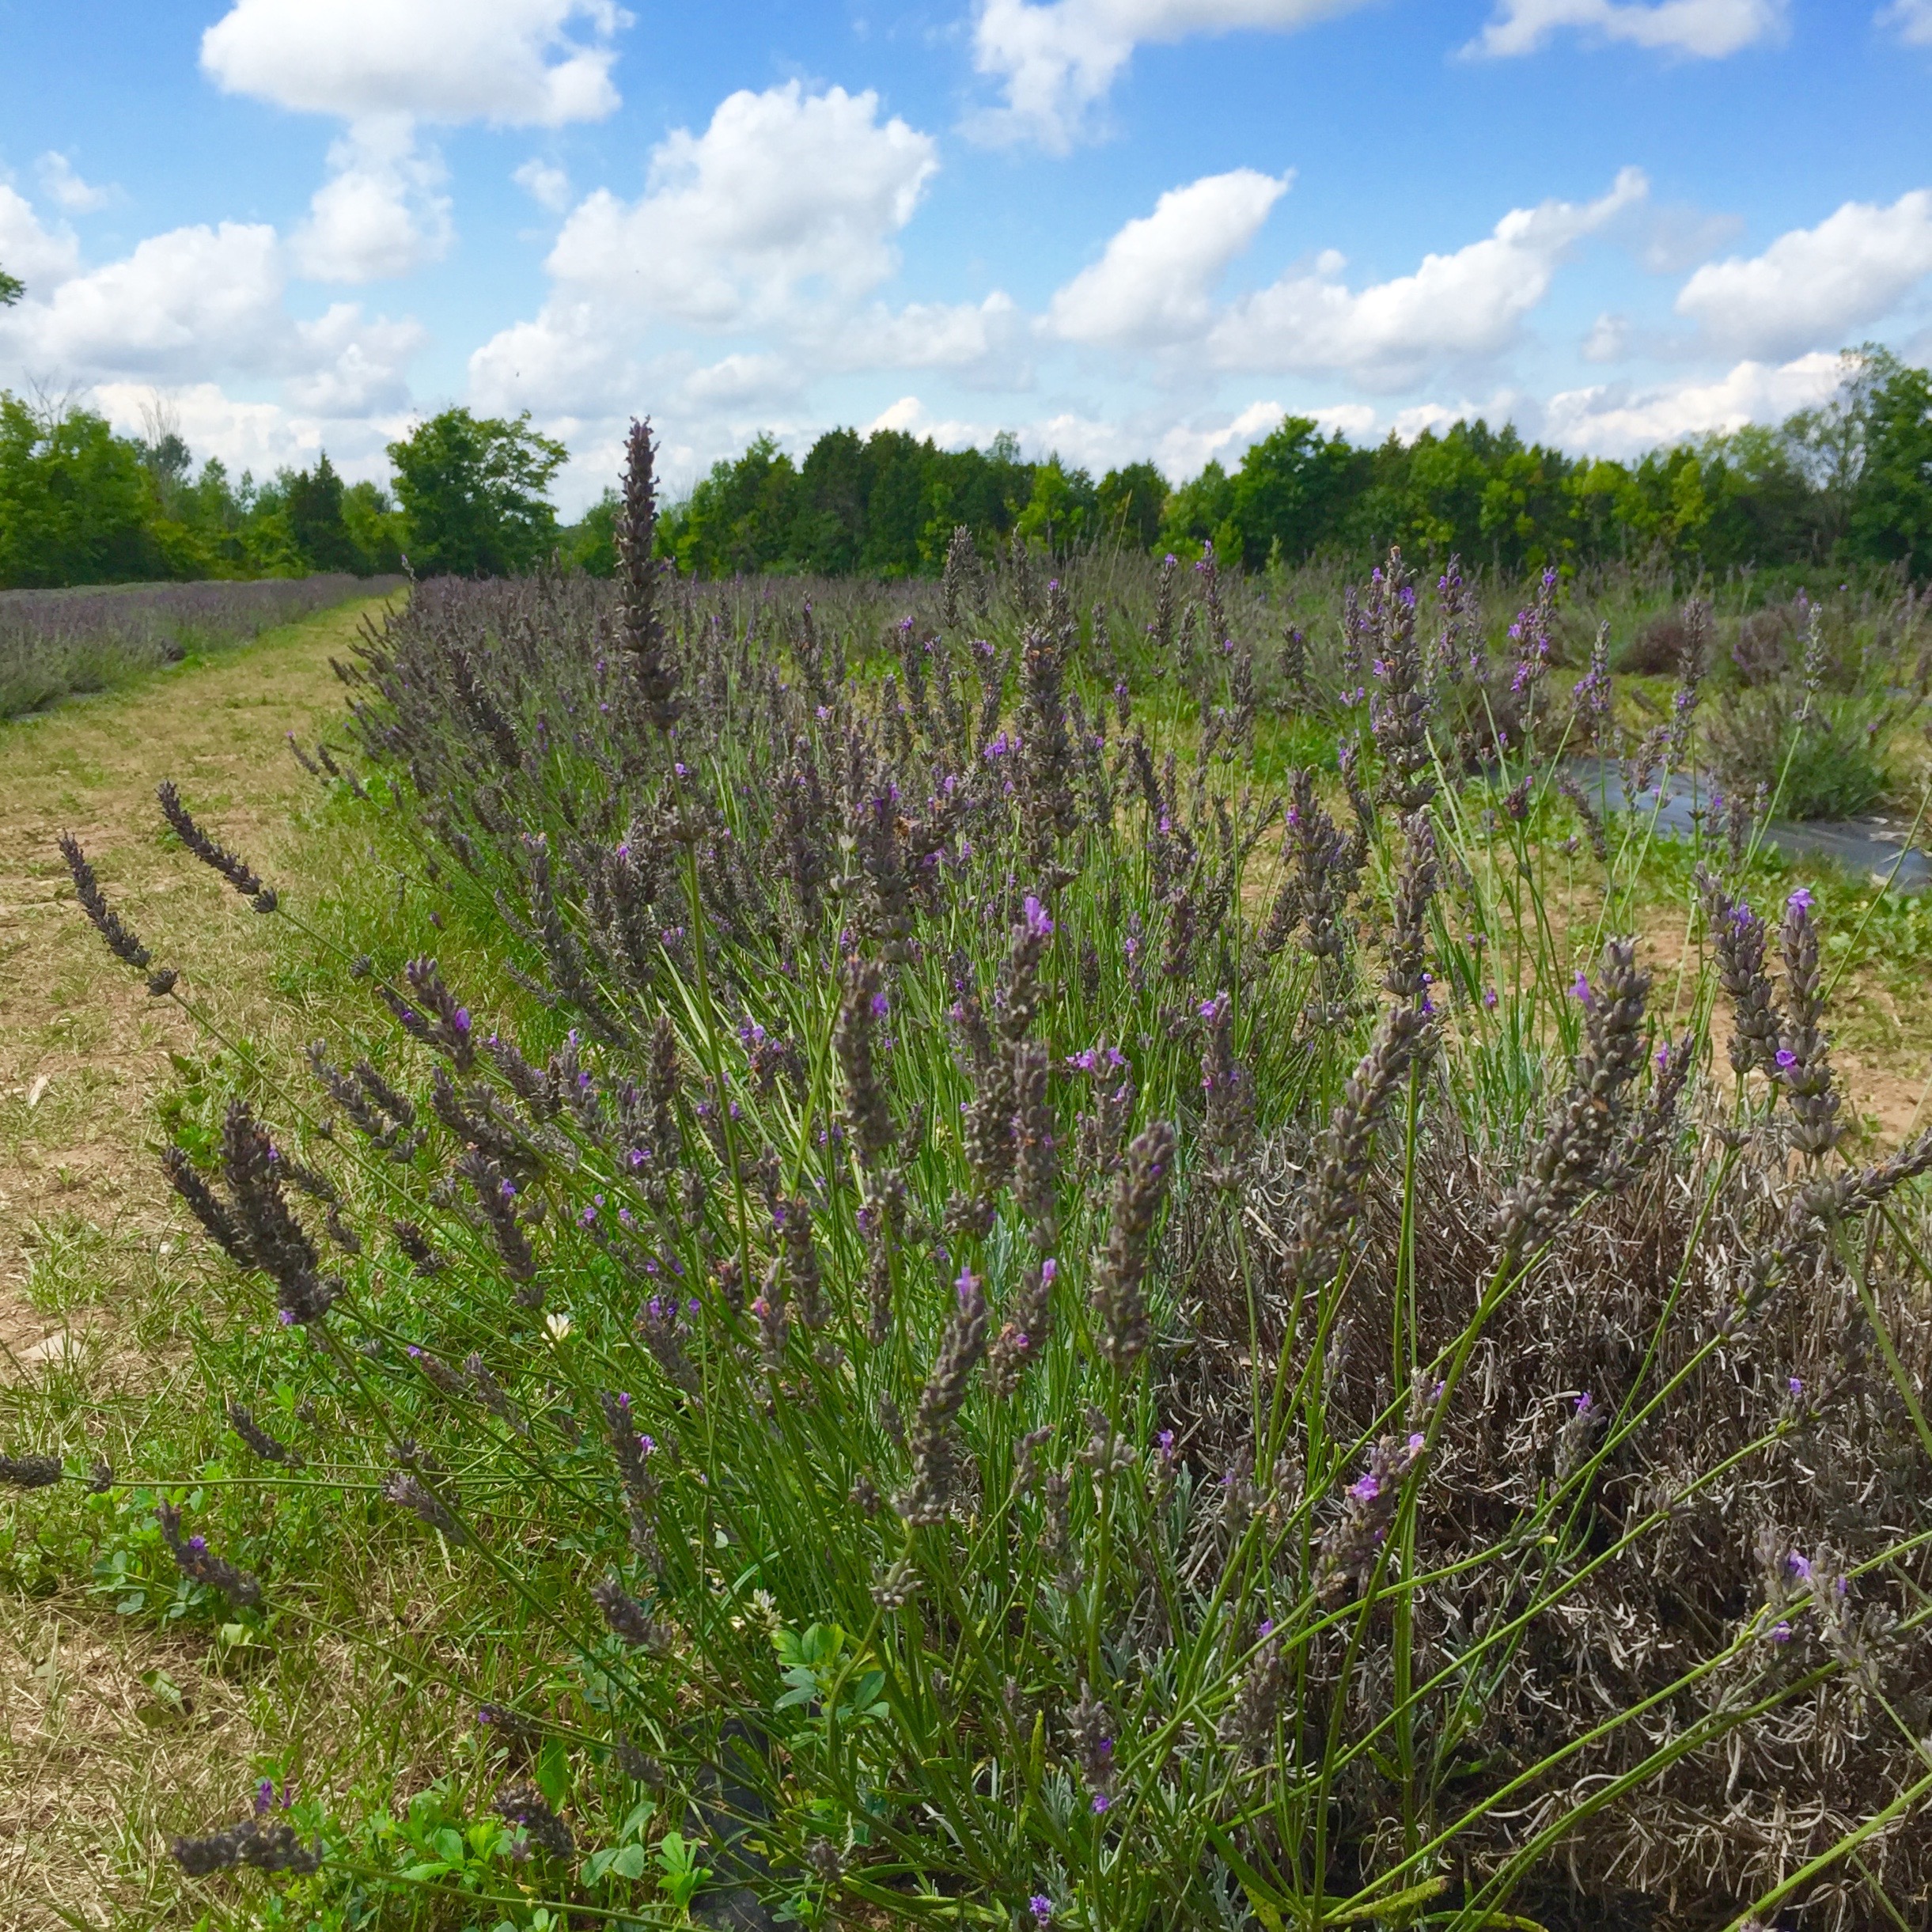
xmin=388 ymin=410 xmax=568 ymax=578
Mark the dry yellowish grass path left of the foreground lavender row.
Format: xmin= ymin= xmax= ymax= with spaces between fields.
xmin=0 ymin=604 xmax=400 ymax=1932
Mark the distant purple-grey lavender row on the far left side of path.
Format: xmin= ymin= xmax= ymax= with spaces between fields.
xmin=0 ymin=572 xmax=402 ymax=718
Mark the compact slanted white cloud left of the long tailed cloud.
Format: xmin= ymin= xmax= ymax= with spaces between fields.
xmin=1045 ymin=168 xmax=1289 ymax=346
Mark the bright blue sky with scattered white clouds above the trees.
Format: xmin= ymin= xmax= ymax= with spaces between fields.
xmin=0 ymin=0 xmax=1932 ymax=508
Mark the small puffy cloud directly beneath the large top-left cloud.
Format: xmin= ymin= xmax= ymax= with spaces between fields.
xmin=290 ymin=116 xmax=450 ymax=282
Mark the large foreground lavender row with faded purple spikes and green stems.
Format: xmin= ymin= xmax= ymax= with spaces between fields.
xmin=26 ymin=429 xmax=1932 ymax=1932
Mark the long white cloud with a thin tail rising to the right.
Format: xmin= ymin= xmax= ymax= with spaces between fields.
xmin=1207 ymin=168 xmax=1648 ymax=388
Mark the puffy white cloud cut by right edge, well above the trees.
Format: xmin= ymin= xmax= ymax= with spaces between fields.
xmin=1677 ymin=188 xmax=1932 ymax=358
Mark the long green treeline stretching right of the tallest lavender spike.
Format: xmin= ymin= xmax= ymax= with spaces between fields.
xmin=622 ymin=348 xmax=1932 ymax=578
